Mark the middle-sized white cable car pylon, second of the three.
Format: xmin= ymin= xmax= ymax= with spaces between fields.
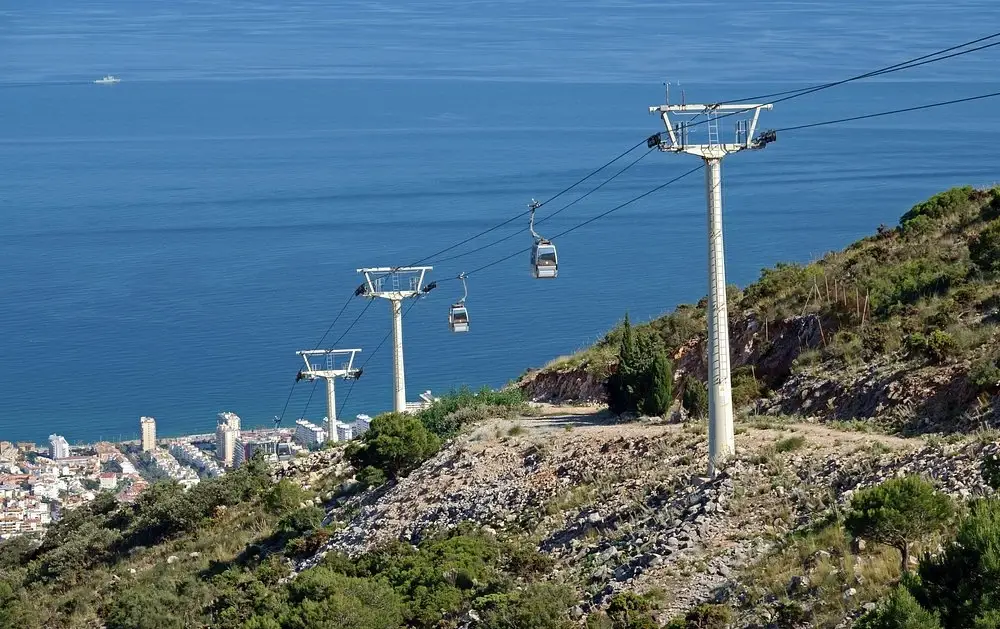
xmin=358 ymin=266 xmax=434 ymax=413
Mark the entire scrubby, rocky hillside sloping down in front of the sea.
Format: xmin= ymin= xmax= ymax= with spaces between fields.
xmin=0 ymin=188 xmax=1000 ymax=629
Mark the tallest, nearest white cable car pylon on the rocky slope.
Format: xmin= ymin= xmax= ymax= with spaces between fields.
xmin=647 ymin=102 xmax=776 ymax=477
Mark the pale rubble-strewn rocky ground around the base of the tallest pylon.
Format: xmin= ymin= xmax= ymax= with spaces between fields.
xmin=298 ymin=413 xmax=997 ymax=626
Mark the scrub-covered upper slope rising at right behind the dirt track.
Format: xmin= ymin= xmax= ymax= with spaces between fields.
xmin=519 ymin=187 xmax=1000 ymax=432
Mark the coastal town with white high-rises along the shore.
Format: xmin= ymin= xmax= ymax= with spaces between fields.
xmin=0 ymin=411 xmax=371 ymax=539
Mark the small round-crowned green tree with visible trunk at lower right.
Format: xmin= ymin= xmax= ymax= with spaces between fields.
xmin=844 ymin=476 xmax=953 ymax=572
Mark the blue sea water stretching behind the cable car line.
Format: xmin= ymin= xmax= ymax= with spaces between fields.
xmin=0 ymin=0 xmax=1000 ymax=441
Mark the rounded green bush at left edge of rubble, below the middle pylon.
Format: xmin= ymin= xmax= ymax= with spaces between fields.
xmin=345 ymin=413 xmax=441 ymax=478
